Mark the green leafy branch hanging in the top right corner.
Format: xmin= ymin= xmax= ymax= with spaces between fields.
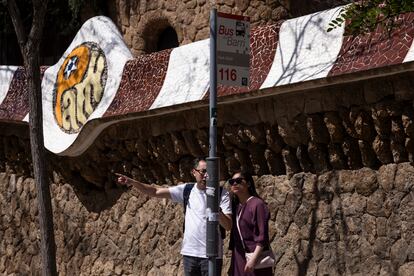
xmin=327 ymin=0 xmax=414 ymax=35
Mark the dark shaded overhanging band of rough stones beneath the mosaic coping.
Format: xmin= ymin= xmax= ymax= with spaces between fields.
xmin=35 ymin=73 xmax=414 ymax=188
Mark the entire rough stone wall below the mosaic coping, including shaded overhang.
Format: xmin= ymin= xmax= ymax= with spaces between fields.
xmin=0 ymin=72 xmax=414 ymax=275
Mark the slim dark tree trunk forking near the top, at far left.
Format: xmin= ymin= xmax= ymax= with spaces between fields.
xmin=7 ymin=0 xmax=57 ymax=276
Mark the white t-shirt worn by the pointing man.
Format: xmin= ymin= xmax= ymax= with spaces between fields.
xmin=169 ymin=183 xmax=231 ymax=259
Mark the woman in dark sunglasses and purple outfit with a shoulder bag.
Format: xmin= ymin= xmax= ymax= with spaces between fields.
xmin=228 ymin=171 xmax=273 ymax=276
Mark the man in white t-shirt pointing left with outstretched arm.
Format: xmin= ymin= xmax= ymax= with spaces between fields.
xmin=116 ymin=158 xmax=232 ymax=276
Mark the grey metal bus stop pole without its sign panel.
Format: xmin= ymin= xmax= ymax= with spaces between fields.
xmin=206 ymin=9 xmax=220 ymax=276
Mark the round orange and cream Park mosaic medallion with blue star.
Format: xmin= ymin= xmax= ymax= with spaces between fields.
xmin=53 ymin=42 xmax=108 ymax=133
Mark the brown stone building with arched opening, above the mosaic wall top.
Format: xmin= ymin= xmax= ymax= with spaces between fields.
xmin=108 ymin=0 xmax=350 ymax=55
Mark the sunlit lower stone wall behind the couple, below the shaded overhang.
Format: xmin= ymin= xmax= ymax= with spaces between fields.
xmin=0 ymin=163 xmax=414 ymax=275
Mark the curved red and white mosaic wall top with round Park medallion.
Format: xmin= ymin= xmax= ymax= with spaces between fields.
xmin=0 ymin=7 xmax=414 ymax=155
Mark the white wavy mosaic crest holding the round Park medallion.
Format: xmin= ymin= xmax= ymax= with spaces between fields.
xmin=38 ymin=16 xmax=132 ymax=156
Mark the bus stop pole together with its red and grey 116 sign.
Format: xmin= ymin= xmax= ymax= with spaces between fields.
xmin=206 ymin=9 xmax=250 ymax=276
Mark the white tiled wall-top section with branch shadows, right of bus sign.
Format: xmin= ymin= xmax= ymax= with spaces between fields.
xmin=265 ymin=10 xmax=342 ymax=87
